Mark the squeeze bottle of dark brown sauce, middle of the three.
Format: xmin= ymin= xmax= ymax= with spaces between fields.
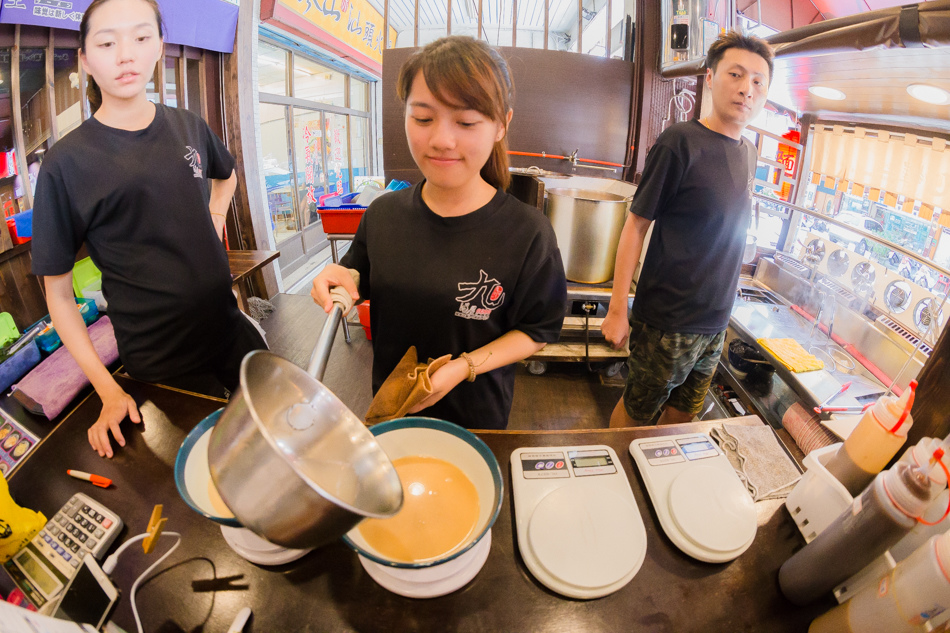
xmin=778 ymin=463 xmax=930 ymax=605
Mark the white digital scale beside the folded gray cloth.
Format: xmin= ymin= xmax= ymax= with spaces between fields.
xmin=630 ymin=433 xmax=758 ymax=563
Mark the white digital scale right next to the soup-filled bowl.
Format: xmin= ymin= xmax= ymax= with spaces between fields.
xmin=511 ymin=446 xmax=647 ymax=599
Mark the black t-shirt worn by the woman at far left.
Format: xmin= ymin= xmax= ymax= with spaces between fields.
xmin=32 ymin=105 xmax=242 ymax=381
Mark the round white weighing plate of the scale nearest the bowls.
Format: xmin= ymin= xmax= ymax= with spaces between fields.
xmin=527 ymin=484 xmax=647 ymax=590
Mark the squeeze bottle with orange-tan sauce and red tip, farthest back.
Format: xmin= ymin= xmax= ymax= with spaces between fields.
xmin=825 ymin=380 xmax=917 ymax=497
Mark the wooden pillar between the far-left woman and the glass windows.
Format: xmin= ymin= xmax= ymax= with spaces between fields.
xmin=223 ymin=2 xmax=277 ymax=299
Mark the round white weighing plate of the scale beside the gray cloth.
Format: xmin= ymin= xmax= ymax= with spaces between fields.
xmin=668 ymin=465 xmax=757 ymax=553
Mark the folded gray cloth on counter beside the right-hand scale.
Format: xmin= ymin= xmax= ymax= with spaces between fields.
xmin=710 ymin=424 xmax=801 ymax=501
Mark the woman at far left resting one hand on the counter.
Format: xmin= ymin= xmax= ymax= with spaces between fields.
xmin=32 ymin=0 xmax=266 ymax=457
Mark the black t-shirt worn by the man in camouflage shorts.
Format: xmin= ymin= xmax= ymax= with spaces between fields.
xmin=631 ymin=121 xmax=756 ymax=334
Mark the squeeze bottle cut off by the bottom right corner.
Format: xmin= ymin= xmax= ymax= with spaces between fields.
xmin=808 ymin=532 xmax=950 ymax=633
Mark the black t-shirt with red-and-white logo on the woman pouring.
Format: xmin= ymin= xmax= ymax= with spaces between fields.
xmin=342 ymin=183 xmax=567 ymax=429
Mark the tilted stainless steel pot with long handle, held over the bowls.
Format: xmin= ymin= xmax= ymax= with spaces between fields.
xmin=208 ymin=296 xmax=403 ymax=549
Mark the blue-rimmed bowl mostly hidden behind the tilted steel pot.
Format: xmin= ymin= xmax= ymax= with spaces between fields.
xmin=175 ymin=409 xmax=244 ymax=527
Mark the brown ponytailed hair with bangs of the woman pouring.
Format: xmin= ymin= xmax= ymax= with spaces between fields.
xmin=397 ymin=35 xmax=514 ymax=191
